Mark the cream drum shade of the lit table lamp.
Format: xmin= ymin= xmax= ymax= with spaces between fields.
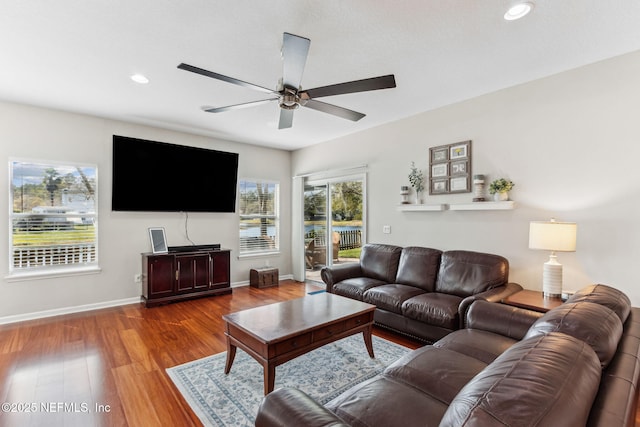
xmin=529 ymin=221 xmax=578 ymax=252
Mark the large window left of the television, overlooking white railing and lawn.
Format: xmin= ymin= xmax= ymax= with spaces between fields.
xmin=9 ymin=160 xmax=98 ymax=274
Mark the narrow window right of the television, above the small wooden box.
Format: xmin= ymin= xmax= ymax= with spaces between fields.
xmin=239 ymin=180 xmax=280 ymax=256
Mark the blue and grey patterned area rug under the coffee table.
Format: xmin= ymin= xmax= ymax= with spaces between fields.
xmin=167 ymin=334 xmax=410 ymax=426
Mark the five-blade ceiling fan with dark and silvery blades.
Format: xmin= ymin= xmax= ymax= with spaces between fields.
xmin=178 ymin=33 xmax=396 ymax=129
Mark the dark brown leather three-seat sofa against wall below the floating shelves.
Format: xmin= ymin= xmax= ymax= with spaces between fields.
xmin=321 ymin=244 xmax=522 ymax=342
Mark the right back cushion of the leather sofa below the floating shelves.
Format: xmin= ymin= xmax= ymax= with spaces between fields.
xmin=435 ymin=251 xmax=509 ymax=298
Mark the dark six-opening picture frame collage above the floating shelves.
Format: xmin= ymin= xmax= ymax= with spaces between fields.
xmin=429 ymin=140 xmax=471 ymax=195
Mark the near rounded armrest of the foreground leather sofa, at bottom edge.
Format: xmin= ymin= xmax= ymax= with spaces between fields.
xmin=255 ymin=388 xmax=348 ymax=427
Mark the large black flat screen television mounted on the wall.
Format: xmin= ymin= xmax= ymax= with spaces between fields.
xmin=111 ymin=135 xmax=238 ymax=212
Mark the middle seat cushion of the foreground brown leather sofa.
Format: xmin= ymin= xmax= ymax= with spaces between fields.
xmin=383 ymin=345 xmax=487 ymax=404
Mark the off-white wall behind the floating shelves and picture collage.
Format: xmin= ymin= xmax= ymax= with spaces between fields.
xmin=292 ymin=52 xmax=640 ymax=306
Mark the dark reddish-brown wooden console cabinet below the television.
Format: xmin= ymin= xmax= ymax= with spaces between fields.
xmin=142 ymin=249 xmax=231 ymax=307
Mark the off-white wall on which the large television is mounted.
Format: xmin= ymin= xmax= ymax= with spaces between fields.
xmin=0 ymin=103 xmax=291 ymax=320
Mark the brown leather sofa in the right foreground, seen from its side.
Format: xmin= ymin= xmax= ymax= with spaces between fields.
xmin=255 ymin=285 xmax=640 ymax=427
